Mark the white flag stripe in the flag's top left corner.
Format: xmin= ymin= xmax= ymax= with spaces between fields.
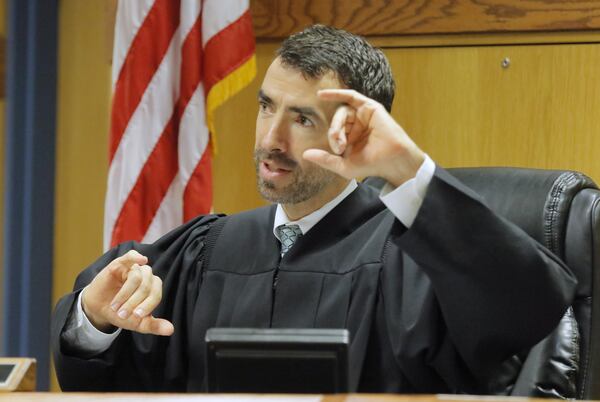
xmin=112 ymin=0 xmax=154 ymax=88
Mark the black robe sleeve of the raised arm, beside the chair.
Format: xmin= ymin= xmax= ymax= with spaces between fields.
xmin=390 ymin=168 xmax=577 ymax=392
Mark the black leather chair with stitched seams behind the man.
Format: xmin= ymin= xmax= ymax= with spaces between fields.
xmin=367 ymin=168 xmax=600 ymax=399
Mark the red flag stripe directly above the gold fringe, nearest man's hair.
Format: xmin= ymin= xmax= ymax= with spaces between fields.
xmin=204 ymin=10 xmax=255 ymax=94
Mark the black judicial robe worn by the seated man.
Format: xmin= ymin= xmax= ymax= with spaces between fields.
xmin=52 ymin=168 xmax=576 ymax=393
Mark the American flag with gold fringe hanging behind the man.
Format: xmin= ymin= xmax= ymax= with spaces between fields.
xmin=104 ymin=0 xmax=256 ymax=249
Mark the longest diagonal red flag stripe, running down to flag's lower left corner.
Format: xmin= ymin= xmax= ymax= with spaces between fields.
xmin=111 ymin=16 xmax=202 ymax=245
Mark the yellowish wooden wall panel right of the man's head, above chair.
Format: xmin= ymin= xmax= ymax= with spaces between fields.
xmin=387 ymin=44 xmax=600 ymax=182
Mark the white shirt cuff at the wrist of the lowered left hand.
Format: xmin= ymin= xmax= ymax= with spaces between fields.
xmin=62 ymin=288 xmax=121 ymax=356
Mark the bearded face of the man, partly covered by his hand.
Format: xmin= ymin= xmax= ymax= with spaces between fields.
xmin=254 ymin=59 xmax=342 ymax=204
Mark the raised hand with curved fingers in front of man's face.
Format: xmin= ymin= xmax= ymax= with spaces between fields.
xmin=303 ymin=89 xmax=425 ymax=187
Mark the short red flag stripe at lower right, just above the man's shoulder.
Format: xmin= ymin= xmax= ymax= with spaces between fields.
xmin=183 ymin=144 xmax=213 ymax=222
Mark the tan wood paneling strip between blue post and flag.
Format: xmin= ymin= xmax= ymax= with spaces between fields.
xmin=48 ymin=0 xmax=110 ymax=390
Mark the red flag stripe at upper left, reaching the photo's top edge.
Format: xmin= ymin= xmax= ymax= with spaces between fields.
xmin=109 ymin=0 xmax=180 ymax=161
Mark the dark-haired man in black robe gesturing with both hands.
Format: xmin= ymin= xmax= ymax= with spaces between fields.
xmin=53 ymin=25 xmax=575 ymax=393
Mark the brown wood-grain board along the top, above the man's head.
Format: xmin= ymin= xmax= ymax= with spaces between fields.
xmin=251 ymin=0 xmax=600 ymax=38
